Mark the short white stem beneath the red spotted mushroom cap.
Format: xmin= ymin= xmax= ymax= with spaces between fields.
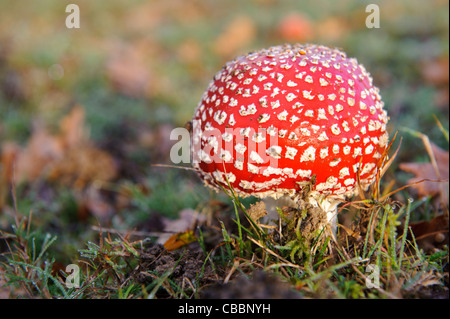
xmin=263 ymin=194 xmax=340 ymax=235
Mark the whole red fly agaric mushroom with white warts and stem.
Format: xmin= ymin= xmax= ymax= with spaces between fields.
xmin=193 ymin=44 xmax=389 ymax=235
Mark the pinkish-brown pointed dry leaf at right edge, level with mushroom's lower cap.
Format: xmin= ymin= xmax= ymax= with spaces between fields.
xmin=399 ymin=142 xmax=449 ymax=202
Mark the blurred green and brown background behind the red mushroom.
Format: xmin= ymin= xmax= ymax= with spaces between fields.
xmin=0 ymin=0 xmax=449 ymax=264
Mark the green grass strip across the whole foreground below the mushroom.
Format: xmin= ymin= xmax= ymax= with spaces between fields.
xmin=0 ymin=162 xmax=448 ymax=299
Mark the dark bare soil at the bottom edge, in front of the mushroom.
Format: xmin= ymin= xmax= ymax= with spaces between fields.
xmin=131 ymin=236 xmax=302 ymax=299
